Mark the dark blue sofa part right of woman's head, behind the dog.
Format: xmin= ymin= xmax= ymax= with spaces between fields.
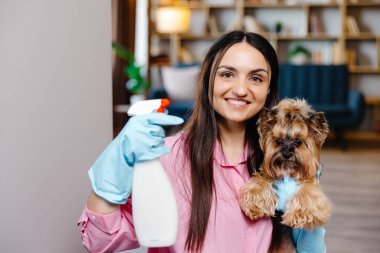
xmin=279 ymin=64 xmax=364 ymax=148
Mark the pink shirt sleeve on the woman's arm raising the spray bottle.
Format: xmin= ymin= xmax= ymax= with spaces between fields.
xmin=78 ymin=199 xmax=139 ymax=253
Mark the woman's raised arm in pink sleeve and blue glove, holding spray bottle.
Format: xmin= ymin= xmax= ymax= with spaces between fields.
xmin=79 ymin=113 xmax=183 ymax=252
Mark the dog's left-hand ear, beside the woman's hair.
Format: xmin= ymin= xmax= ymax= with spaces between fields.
xmin=257 ymin=108 xmax=276 ymax=150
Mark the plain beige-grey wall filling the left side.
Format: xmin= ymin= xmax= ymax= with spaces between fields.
xmin=0 ymin=0 xmax=112 ymax=253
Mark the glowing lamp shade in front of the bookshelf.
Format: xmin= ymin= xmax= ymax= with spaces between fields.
xmin=156 ymin=6 xmax=190 ymax=33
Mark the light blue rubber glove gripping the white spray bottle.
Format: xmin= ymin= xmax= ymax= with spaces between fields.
xmin=88 ymin=113 xmax=183 ymax=204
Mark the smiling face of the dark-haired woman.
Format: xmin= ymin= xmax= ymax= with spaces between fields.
xmin=213 ymin=42 xmax=271 ymax=128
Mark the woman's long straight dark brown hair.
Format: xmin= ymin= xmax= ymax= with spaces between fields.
xmin=181 ymin=31 xmax=278 ymax=252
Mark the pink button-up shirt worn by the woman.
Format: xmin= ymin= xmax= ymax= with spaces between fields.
xmin=79 ymin=134 xmax=272 ymax=253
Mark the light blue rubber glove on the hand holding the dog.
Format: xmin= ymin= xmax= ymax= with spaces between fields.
xmin=273 ymin=176 xmax=326 ymax=253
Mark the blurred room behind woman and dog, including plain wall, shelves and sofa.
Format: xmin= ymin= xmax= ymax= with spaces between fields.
xmin=0 ymin=0 xmax=380 ymax=253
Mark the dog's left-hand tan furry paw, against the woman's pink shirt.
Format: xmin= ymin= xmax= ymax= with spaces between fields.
xmin=239 ymin=179 xmax=277 ymax=220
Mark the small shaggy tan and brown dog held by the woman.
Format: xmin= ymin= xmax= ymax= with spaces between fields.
xmin=239 ymin=99 xmax=331 ymax=252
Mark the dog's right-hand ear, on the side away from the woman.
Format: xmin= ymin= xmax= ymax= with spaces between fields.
xmin=308 ymin=112 xmax=329 ymax=146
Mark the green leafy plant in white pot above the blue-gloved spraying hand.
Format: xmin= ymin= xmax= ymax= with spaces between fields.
xmin=112 ymin=42 xmax=151 ymax=104
